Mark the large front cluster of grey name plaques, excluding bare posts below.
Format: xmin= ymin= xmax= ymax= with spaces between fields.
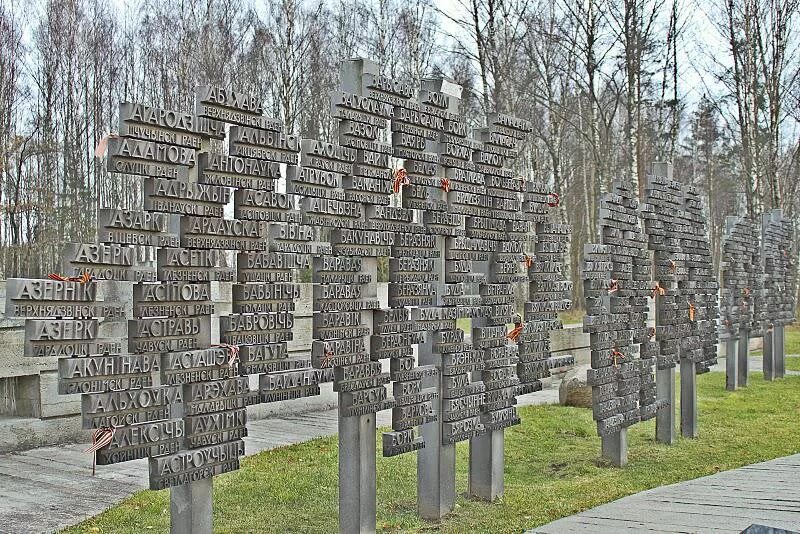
xmin=7 ymin=56 xmax=572 ymax=532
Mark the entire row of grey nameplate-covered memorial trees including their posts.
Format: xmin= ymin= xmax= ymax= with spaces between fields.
xmin=5 ymin=49 xmax=797 ymax=533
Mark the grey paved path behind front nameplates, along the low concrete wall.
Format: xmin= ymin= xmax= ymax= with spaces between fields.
xmin=0 ymin=381 xmax=559 ymax=534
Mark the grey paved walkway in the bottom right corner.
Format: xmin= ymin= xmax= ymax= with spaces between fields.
xmin=529 ymin=454 xmax=800 ymax=534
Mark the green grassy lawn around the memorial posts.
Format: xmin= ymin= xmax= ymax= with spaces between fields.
xmin=67 ymin=373 xmax=800 ymax=533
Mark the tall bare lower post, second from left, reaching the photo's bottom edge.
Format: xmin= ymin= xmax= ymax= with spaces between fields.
xmin=339 ymin=413 xmax=376 ymax=534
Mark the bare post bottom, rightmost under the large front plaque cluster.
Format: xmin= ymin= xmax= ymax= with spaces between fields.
xmin=469 ymin=428 xmax=505 ymax=501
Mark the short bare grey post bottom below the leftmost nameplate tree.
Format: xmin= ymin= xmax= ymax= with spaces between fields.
xmin=169 ymin=477 xmax=214 ymax=534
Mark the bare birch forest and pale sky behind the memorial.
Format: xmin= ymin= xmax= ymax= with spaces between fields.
xmin=0 ymin=0 xmax=800 ymax=310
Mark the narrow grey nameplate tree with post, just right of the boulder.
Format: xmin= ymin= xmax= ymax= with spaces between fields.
xmin=582 ymin=182 xmax=666 ymax=466
